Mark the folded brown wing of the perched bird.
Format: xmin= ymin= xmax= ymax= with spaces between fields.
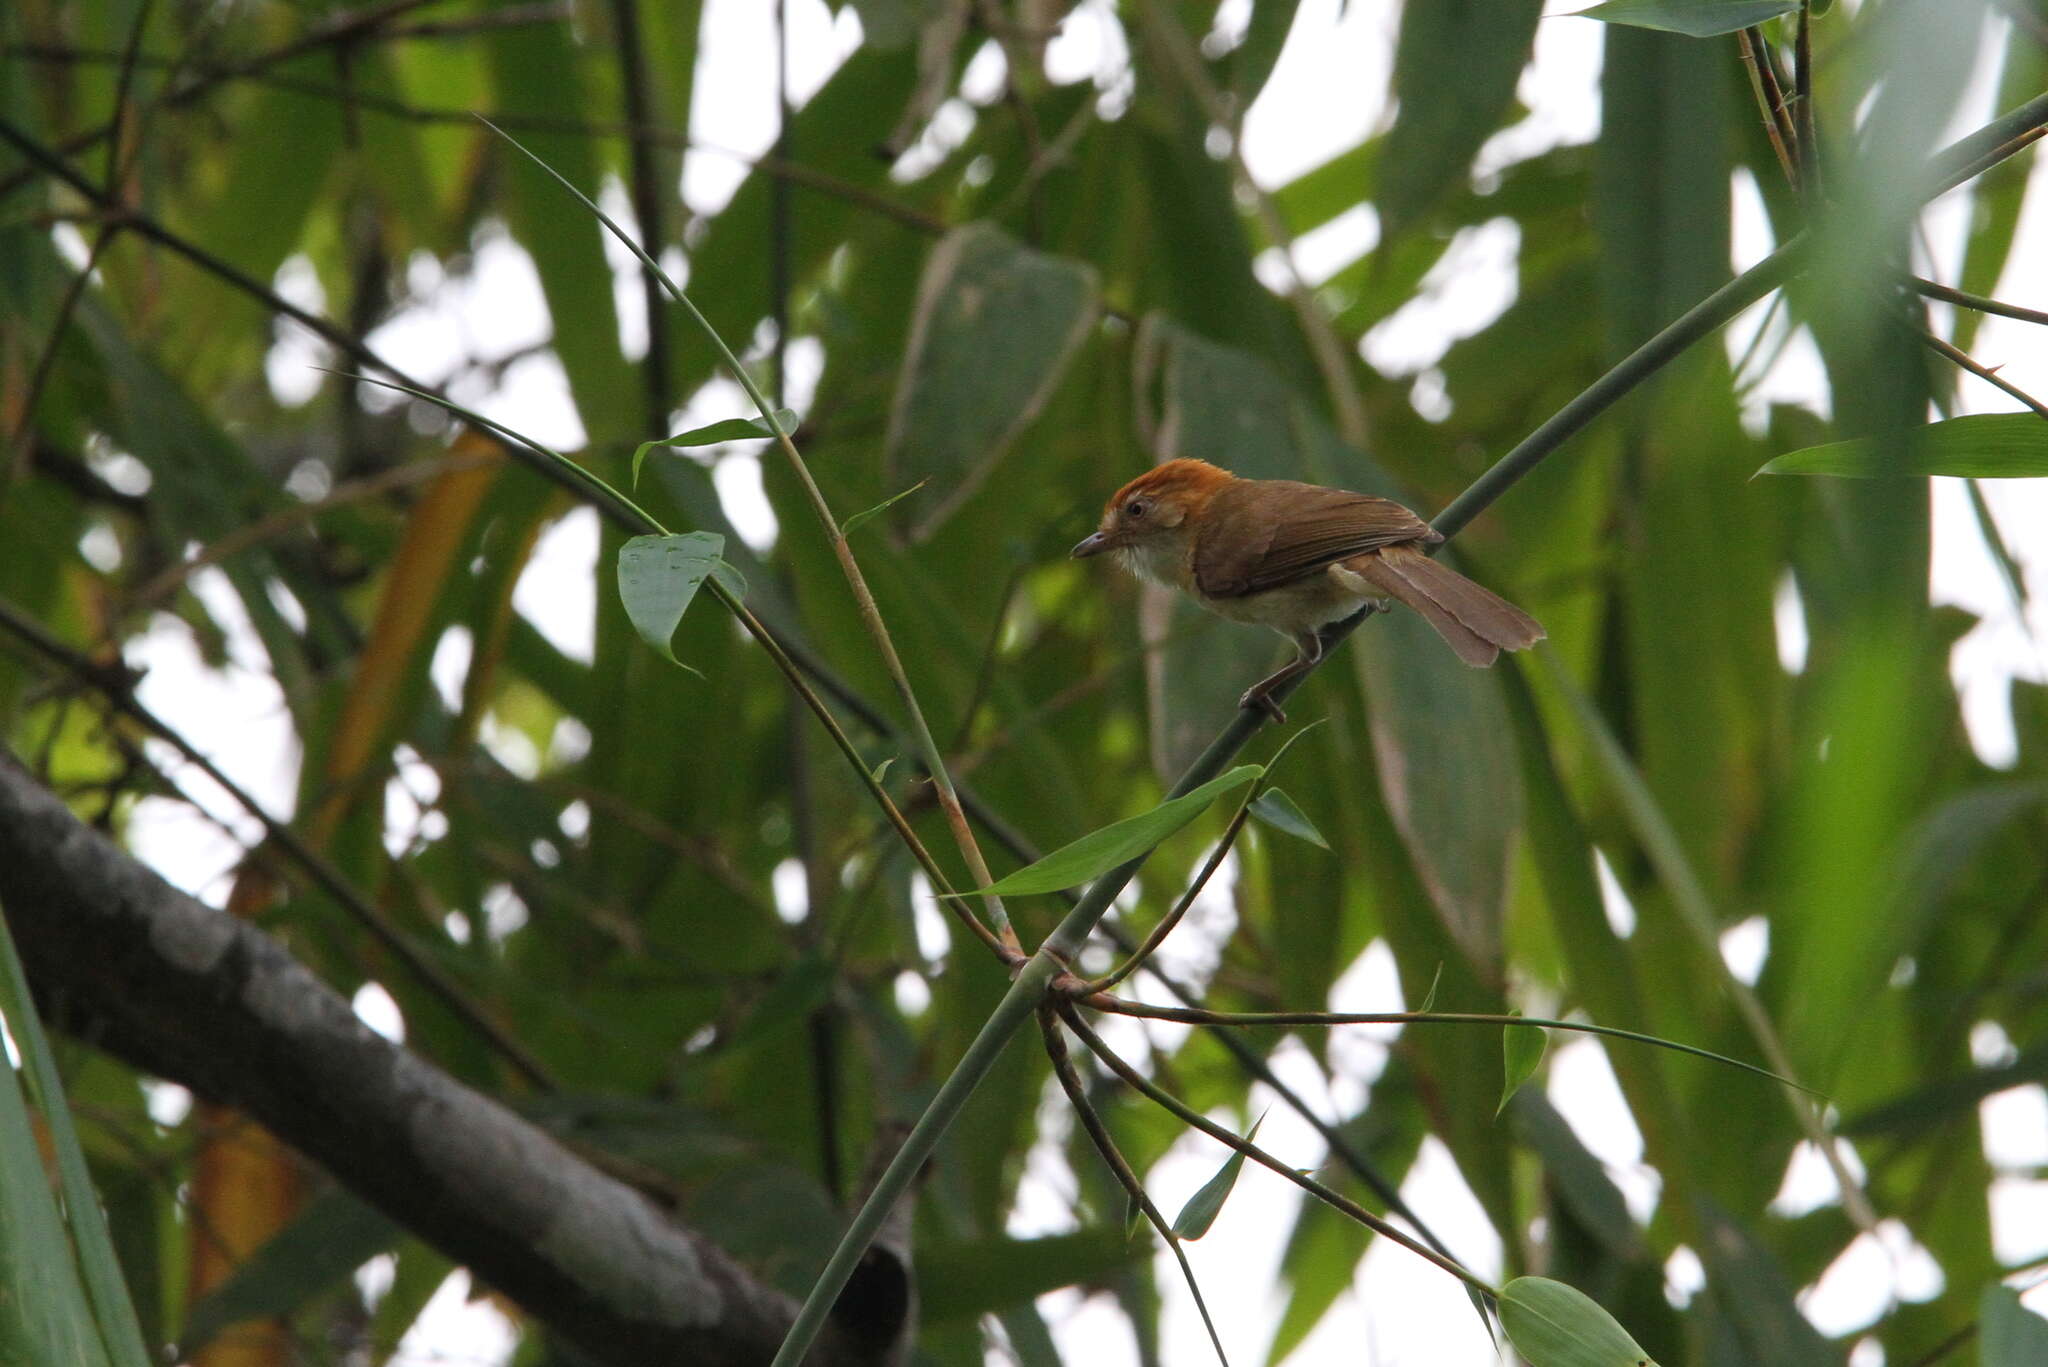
xmin=1194 ymin=480 xmax=1440 ymax=598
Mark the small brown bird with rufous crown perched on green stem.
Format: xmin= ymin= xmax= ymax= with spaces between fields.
xmin=1073 ymin=459 xmax=1544 ymax=719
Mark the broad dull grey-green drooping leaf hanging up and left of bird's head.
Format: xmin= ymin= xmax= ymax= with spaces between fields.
xmin=887 ymin=223 xmax=1098 ymax=539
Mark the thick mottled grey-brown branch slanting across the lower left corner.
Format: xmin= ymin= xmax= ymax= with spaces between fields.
xmin=0 ymin=754 xmax=901 ymax=1367
